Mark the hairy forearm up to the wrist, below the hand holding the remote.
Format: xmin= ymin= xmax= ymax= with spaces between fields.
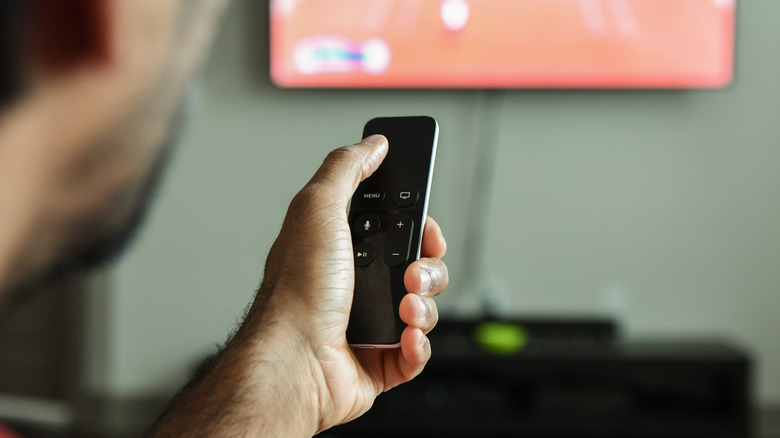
xmin=147 ymin=308 xmax=319 ymax=437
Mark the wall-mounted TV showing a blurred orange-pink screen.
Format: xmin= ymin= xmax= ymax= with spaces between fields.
xmin=270 ymin=0 xmax=736 ymax=88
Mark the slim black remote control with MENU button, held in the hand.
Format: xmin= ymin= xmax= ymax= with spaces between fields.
xmin=347 ymin=116 xmax=439 ymax=348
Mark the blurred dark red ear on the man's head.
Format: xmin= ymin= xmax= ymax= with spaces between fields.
xmin=30 ymin=0 xmax=113 ymax=73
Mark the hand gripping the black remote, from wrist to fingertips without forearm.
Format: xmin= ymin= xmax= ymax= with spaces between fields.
xmin=250 ymin=136 xmax=449 ymax=432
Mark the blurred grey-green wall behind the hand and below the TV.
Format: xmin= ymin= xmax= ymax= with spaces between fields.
xmin=103 ymin=0 xmax=780 ymax=402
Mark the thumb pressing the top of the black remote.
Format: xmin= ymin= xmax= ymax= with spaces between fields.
xmin=309 ymin=135 xmax=388 ymax=204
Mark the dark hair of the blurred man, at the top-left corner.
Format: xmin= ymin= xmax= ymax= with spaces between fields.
xmin=0 ymin=0 xmax=27 ymax=109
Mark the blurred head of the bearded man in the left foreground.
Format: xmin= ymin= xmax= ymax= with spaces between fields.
xmin=0 ymin=0 xmax=226 ymax=306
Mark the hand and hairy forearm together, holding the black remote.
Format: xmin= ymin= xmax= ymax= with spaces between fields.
xmin=145 ymin=136 xmax=449 ymax=438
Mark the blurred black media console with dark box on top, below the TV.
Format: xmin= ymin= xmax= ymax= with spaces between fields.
xmin=322 ymin=320 xmax=751 ymax=438
